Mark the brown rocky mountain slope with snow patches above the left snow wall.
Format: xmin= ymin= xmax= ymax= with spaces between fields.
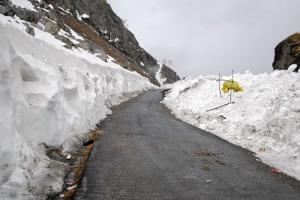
xmin=0 ymin=0 xmax=180 ymax=85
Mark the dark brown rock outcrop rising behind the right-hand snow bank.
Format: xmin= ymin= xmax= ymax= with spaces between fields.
xmin=273 ymin=33 xmax=300 ymax=72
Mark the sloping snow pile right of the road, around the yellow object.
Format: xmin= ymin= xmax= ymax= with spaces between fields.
xmin=163 ymin=70 xmax=300 ymax=180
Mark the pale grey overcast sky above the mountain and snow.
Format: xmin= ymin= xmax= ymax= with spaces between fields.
xmin=108 ymin=0 xmax=300 ymax=77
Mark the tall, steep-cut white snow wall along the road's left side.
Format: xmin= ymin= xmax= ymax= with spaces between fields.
xmin=0 ymin=15 xmax=152 ymax=200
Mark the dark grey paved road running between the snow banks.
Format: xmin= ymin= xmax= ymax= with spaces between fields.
xmin=75 ymin=90 xmax=300 ymax=200
